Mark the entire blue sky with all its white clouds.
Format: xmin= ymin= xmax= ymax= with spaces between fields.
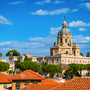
xmin=0 ymin=0 xmax=90 ymax=56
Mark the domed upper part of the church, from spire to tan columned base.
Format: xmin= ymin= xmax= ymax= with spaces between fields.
xmin=50 ymin=19 xmax=80 ymax=56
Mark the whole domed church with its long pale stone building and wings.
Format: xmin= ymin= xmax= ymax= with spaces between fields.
xmin=9 ymin=19 xmax=90 ymax=76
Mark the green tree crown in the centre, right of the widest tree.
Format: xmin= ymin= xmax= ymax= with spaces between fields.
xmin=42 ymin=64 xmax=63 ymax=77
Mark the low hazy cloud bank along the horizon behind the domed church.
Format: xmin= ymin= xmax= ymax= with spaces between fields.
xmin=0 ymin=34 xmax=90 ymax=56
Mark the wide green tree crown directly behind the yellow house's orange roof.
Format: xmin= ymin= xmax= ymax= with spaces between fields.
xmin=19 ymin=61 xmax=41 ymax=72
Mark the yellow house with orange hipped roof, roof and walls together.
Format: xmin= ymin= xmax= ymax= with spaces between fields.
xmin=10 ymin=70 xmax=44 ymax=90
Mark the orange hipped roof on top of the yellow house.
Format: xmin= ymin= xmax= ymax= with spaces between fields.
xmin=11 ymin=70 xmax=44 ymax=80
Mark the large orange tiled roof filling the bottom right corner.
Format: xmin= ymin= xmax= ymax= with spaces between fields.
xmin=50 ymin=78 xmax=90 ymax=90
